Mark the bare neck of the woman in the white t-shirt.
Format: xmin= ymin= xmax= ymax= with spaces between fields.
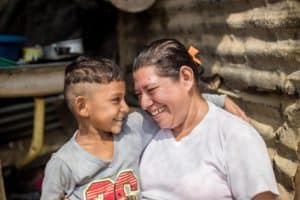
xmin=172 ymin=96 xmax=208 ymax=141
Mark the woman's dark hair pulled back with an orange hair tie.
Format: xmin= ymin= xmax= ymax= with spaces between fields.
xmin=133 ymin=39 xmax=200 ymax=85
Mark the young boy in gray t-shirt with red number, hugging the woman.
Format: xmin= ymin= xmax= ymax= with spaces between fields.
xmin=41 ymin=57 xmax=234 ymax=200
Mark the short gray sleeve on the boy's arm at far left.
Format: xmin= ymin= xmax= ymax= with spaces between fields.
xmin=41 ymin=156 xmax=72 ymax=200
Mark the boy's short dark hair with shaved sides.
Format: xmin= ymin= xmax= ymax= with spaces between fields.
xmin=63 ymin=56 xmax=124 ymax=112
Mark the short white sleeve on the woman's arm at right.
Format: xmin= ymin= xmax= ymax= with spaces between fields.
xmin=225 ymin=125 xmax=278 ymax=200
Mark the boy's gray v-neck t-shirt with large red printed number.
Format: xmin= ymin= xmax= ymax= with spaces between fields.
xmin=41 ymin=112 xmax=158 ymax=200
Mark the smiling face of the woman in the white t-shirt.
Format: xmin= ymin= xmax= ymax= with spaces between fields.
xmin=133 ymin=66 xmax=189 ymax=129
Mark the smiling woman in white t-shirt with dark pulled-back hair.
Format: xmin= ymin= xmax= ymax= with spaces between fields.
xmin=133 ymin=39 xmax=278 ymax=200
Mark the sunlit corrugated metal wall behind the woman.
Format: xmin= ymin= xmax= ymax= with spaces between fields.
xmin=118 ymin=0 xmax=300 ymax=200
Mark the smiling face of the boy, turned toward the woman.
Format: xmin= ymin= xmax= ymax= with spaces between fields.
xmin=87 ymin=81 xmax=129 ymax=134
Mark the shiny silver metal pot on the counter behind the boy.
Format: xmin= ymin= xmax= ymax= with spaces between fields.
xmin=43 ymin=39 xmax=83 ymax=60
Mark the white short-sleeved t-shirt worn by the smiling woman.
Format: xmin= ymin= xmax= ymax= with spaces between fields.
xmin=140 ymin=103 xmax=278 ymax=200
